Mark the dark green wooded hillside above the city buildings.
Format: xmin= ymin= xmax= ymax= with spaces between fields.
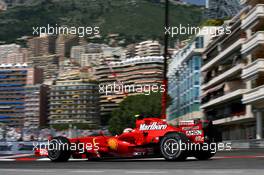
xmin=0 ymin=0 xmax=203 ymax=42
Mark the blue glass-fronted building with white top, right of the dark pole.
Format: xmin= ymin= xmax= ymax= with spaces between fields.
xmin=167 ymin=27 xmax=211 ymax=124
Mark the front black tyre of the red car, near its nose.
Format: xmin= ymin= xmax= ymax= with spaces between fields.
xmin=48 ymin=137 xmax=71 ymax=162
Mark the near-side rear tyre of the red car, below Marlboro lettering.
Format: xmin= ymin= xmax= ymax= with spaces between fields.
xmin=160 ymin=133 xmax=188 ymax=161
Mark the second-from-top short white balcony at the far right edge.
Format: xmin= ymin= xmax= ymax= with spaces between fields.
xmin=241 ymin=31 xmax=264 ymax=54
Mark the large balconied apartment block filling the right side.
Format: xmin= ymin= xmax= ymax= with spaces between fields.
xmin=201 ymin=0 xmax=264 ymax=140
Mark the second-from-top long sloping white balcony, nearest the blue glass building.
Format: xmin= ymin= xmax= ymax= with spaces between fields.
xmin=202 ymin=63 xmax=244 ymax=90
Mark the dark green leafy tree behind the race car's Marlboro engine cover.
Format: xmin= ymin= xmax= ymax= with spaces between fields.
xmin=109 ymin=93 xmax=171 ymax=134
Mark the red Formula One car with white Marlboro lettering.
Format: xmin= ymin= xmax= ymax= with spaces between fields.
xmin=35 ymin=118 xmax=220 ymax=162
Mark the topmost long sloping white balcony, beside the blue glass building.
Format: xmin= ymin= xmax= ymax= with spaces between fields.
xmin=201 ymin=38 xmax=245 ymax=72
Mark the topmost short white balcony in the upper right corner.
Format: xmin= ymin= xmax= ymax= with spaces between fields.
xmin=241 ymin=4 xmax=264 ymax=29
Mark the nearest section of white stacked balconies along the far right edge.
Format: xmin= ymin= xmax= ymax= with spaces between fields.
xmin=241 ymin=0 xmax=264 ymax=139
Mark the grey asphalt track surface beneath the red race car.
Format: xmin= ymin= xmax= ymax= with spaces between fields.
xmin=0 ymin=149 xmax=264 ymax=175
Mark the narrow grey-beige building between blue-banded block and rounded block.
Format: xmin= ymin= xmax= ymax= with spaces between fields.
xmin=24 ymin=84 xmax=49 ymax=129
